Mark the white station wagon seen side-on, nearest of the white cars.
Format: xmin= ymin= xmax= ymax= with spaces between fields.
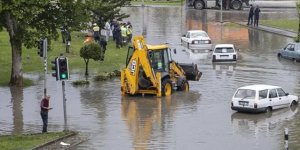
xmin=231 ymin=84 xmax=298 ymax=113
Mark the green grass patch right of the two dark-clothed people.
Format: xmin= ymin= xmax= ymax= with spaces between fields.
xmin=259 ymin=20 xmax=299 ymax=32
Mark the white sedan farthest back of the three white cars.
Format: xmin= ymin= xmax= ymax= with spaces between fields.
xmin=181 ymin=30 xmax=212 ymax=50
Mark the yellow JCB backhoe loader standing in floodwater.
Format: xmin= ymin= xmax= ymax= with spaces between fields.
xmin=121 ymin=36 xmax=202 ymax=97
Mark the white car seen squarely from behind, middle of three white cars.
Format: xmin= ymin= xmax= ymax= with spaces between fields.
xmin=212 ymin=44 xmax=238 ymax=62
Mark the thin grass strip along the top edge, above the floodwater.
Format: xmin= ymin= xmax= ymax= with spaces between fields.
xmin=131 ymin=0 xmax=185 ymax=6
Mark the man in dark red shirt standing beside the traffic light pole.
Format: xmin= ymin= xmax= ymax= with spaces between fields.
xmin=41 ymin=95 xmax=52 ymax=133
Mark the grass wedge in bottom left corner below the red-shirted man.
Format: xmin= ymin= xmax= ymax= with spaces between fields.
xmin=0 ymin=132 xmax=69 ymax=150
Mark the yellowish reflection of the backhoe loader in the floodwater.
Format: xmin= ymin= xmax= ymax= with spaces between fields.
xmin=121 ymin=91 xmax=200 ymax=149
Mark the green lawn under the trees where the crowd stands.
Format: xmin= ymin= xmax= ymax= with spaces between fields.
xmin=0 ymin=31 xmax=128 ymax=86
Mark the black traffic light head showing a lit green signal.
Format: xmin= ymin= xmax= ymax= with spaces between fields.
xmin=58 ymin=57 xmax=69 ymax=80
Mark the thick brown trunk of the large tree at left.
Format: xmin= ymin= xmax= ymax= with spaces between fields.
xmin=5 ymin=12 xmax=23 ymax=86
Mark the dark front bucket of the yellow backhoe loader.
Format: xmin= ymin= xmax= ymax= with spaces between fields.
xmin=179 ymin=63 xmax=202 ymax=81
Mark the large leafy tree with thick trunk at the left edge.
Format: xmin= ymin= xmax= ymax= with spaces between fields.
xmin=0 ymin=0 xmax=130 ymax=86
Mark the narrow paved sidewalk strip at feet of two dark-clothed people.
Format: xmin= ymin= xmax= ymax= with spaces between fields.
xmin=234 ymin=22 xmax=297 ymax=38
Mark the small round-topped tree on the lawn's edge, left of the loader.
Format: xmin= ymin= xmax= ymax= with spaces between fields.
xmin=80 ymin=42 xmax=104 ymax=76
